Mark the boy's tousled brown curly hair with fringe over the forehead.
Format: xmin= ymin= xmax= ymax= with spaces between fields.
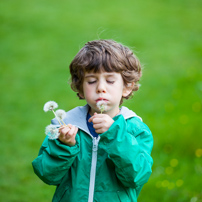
xmin=69 ymin=40 xmax=142 ymax=103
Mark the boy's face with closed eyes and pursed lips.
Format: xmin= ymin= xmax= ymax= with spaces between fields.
xmin=81 ymin=72 xmax=131 ymax=118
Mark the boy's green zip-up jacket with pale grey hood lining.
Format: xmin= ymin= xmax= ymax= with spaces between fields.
xmin=32 ymin=105 xmax=153 ymax=202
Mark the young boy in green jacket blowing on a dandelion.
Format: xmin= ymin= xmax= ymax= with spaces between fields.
xmin=33 ymin=40 xmax=153 ymax=202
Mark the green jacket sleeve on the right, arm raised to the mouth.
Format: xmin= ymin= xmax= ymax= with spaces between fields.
xmin=100 ymin=115 xmax=153 ymax=189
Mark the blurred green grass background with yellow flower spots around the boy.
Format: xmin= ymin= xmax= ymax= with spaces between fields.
xmin=0 ymin=0 xmax=202 ymax=202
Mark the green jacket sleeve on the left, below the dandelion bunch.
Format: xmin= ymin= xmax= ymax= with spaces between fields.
xmin=32 ymin=134 xmax=80 ymax=185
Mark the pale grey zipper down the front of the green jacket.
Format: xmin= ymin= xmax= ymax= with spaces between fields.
xmin=88 ymin=136 xmax=100 ymax=202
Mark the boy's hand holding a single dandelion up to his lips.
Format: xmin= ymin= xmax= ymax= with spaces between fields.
xmin=88 ymin=113 xmax=114 ymax=134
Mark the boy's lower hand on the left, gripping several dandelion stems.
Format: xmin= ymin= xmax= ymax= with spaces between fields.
xmin=58 ymin=124 xmax=78 ymax=146
